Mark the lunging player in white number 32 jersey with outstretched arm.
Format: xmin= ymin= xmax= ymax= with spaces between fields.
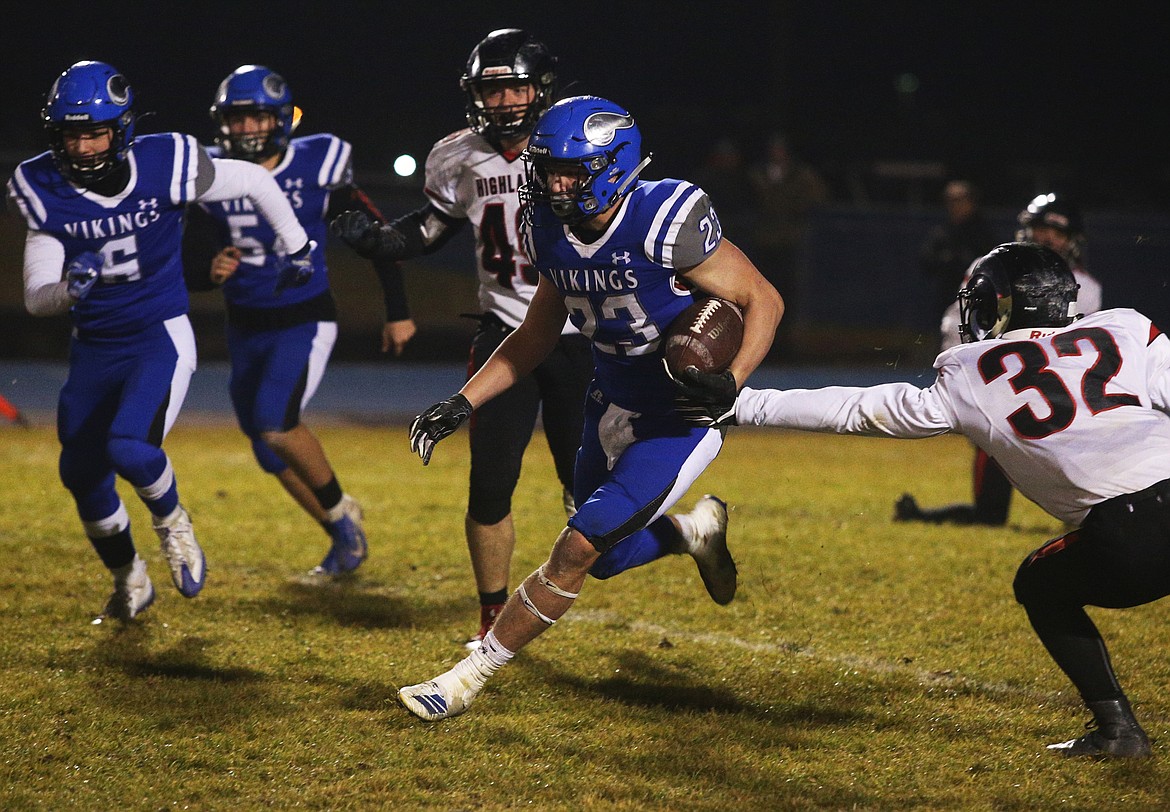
xmin=716 ymin=242 xmax=1170 ymax=757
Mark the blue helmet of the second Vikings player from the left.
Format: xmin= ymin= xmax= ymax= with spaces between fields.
xmin=211 ymin=64 xmax=301 ymax=161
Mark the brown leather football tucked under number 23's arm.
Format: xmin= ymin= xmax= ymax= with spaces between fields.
xmin=662 ymin=298 xmax=743 ymax=378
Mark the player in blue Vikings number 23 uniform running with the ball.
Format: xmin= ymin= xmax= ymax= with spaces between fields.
xmin=399 ymin=96 xmax=784 ymax=721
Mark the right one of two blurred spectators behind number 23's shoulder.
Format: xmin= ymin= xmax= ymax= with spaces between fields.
xmin=748 ymin=132 xmax=828 ymax=325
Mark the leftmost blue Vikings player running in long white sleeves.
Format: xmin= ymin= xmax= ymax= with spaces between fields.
xmin=8 ymin=61 xmax=314 ymax=622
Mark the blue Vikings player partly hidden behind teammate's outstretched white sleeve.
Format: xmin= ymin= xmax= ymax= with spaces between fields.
xmin=184 ymin=64 xmax=414 ymax=577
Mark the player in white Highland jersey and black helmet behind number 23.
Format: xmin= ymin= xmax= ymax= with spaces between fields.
xmin=332 ymin=28 xmax=593 ymax=648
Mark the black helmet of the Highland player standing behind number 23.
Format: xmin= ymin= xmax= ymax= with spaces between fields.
xmin=459 ymin=28 xmax=557 ymax=144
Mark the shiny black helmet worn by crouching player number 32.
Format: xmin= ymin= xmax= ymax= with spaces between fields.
xmin=958 ymin=242 xmax=1078 ymax=344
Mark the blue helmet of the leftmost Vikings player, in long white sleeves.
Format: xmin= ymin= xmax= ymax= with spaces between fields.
xmin=41 ymin=61 xmax=135 ymax=186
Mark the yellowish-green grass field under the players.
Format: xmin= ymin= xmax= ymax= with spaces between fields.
xmin=0 ymin=420 xmax=1170 ymax=810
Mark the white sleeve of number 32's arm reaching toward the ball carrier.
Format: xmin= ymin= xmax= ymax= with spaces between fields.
xmin=735 ymin=384 xmax=954 ymax=439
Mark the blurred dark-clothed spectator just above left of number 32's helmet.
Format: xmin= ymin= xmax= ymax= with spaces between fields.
xmin=918 ymin=180 xmax=997 ymax=318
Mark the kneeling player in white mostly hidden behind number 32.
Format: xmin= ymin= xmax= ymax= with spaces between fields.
xmin=894 ymin=193 xmax=1101 ymax=525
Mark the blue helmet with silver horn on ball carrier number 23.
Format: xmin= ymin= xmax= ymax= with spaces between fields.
xmin=519 ymin=96 xmax=651 ymax=225
